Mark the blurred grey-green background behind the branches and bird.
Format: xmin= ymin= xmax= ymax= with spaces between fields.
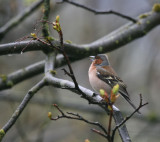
xmin=0 ymin=0 xmax=160 ymax=142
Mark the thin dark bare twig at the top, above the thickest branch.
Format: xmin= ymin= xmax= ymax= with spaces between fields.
xmin=57 ymin=0 xmax=137 ymax=23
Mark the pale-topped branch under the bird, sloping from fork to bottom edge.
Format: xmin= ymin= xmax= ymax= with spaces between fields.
xmin=46 ymin=75 xmax=131 ymax=142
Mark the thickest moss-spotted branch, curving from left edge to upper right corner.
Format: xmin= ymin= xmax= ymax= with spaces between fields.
xmin=0 ymin=12 xmax=160 ymax=56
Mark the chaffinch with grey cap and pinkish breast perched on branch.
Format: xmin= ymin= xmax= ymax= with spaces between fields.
xmin=88 ymin=54 xmax=136 ymax=109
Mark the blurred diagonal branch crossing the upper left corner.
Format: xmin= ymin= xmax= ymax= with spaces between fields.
xmin=0 ymin=0 xmax=43 ymax=40
